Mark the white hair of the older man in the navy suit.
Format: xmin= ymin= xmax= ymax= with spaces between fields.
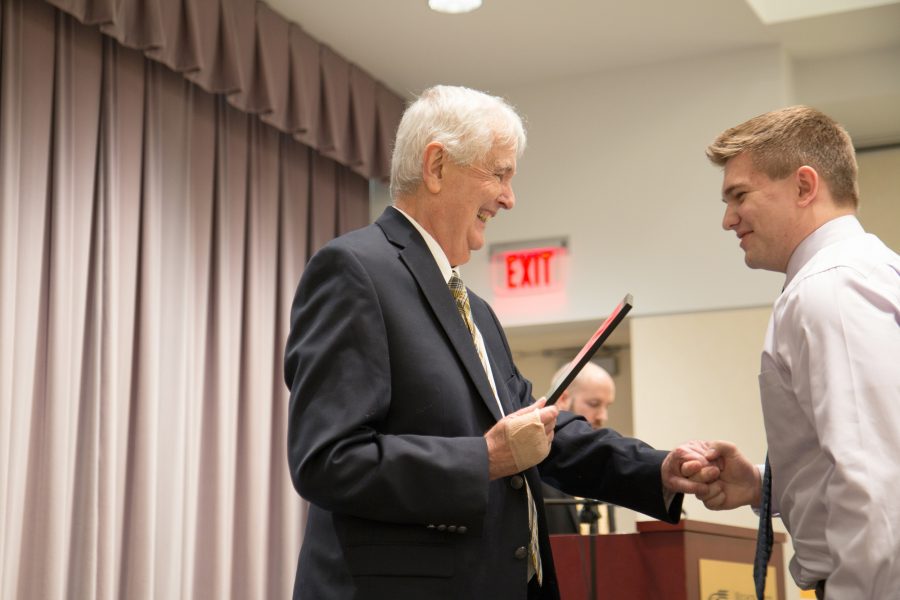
xmin=391 ymin=85 xmax=525 ymax=200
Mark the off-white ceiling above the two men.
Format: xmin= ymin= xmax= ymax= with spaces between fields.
xmin=265 ymin=0 xmax=900 ymax=97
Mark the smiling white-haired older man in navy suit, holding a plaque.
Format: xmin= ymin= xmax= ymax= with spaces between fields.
xmin=285 ymin=86 xmax=717 ymax=600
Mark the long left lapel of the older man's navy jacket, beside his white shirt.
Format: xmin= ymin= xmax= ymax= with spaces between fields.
xmin=376 ymin=208 xmax=501 ymax=420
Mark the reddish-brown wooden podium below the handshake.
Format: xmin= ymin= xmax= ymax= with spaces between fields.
xmin=550 ymin=520 xmax=785 ymax=600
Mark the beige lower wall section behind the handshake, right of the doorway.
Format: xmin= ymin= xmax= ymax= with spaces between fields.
xmin=631 ymin=307 xmax=800 ymax=599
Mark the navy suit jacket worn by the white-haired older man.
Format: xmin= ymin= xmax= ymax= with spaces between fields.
xmin=285 ymin=208 xmax=681 ymax=600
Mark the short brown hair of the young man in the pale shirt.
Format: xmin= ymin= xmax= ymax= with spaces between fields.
xmin=706 ymin=105 xmax=859 ymax=207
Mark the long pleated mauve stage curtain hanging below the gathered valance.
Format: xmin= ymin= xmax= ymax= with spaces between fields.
xmin=0 ymin=0 xmax=377 ymax=600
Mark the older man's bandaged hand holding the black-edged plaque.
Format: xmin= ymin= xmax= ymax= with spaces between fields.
xmin=484 ymin=398 xmax=559 ymax=480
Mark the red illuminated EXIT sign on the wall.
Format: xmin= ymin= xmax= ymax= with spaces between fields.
xmin=491 ymin=240 xmax=568 ymax=295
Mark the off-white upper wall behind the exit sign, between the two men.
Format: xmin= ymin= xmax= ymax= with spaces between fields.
xmin=463 ymin=48 xmax=790 ymax=326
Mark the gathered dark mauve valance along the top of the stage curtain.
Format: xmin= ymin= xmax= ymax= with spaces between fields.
xmin=44 ymin=0 xmax=404 ymax=179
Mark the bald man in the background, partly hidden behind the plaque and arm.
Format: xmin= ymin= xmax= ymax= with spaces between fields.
xmin=543 ymin=362 xmax=616 ymax=534
